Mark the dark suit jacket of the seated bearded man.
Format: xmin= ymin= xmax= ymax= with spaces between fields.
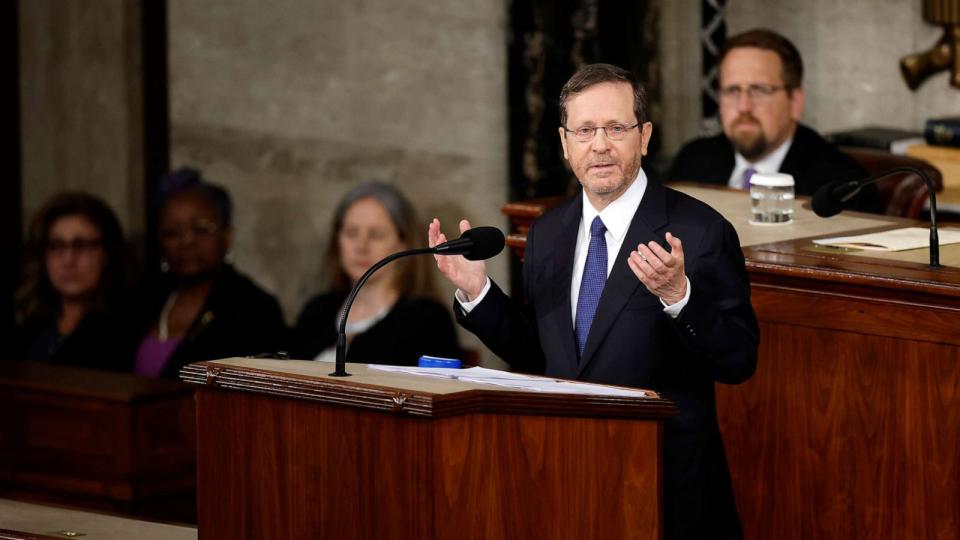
xmin=667 ymin=124 xmax=884 ymax=214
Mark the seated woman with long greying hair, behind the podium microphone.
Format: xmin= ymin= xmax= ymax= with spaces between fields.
xmin=290 ymin=182 xmax=460 ymax=365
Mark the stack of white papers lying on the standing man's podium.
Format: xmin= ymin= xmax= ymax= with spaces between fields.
xmin=367 ymin=364 xmax=652 ymax=397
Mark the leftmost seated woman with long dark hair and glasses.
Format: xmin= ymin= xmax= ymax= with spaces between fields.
xmin=13 ymin=193 xmax=131 ymax=370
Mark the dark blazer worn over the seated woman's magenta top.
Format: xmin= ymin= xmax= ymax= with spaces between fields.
xmin=131 ymin=265 xmax=289 ymax=378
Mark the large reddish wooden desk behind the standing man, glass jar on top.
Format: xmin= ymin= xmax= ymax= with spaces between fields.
xmin=502 ymin=185 xmax=960 ymax=539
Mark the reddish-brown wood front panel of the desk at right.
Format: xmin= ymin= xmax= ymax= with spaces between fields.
xmin=717 ymin=276 xmax=960 ymax=539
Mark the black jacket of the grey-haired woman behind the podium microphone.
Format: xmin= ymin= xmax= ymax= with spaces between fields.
xmin=290 ymin=292 xmax=460 ymax=366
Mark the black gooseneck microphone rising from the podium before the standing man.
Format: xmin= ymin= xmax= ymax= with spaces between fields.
xmin=330 ymin=227 xmax=505 ymax=377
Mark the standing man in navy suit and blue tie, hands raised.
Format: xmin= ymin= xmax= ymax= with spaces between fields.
xmin=428 ymin=64 xmax=759 ymax=539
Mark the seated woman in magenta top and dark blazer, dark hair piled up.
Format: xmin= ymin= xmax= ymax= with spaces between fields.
xmin=134 ymin=169 xmax=287 ymax=378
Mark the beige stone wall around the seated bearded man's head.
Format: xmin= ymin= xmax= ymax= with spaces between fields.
xmin=661 ymin=0 xmax=960 ymax=153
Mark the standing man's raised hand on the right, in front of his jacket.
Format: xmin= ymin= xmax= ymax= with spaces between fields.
xmin=627 ymin=233 xmax=687 ymax=305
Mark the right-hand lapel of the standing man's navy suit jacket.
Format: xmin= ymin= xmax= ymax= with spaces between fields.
xmin=568 ymin=180 xmax=669 ymax=376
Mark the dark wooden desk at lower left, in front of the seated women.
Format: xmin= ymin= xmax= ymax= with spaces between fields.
xmin=0 ymin=362 xmax=196 ymax=522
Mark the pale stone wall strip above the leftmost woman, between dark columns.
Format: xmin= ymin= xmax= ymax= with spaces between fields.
xmin=18 ymin=0 xmax=145 ymax=236
